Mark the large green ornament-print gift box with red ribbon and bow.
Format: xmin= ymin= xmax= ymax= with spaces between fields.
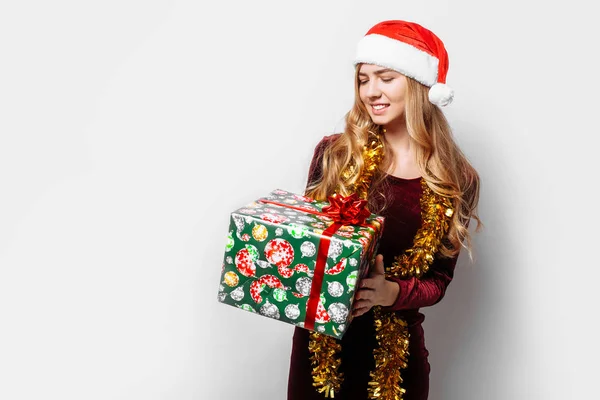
xmin=218 ymin=189 xmax=384 ymax=338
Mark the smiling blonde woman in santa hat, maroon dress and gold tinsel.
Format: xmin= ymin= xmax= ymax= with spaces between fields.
xmin=288 ymin=21 xmax=480 ymax=400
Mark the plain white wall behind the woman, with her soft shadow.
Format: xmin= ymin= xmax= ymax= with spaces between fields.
xmin=0 ymin=0 xmax=600 ymax=400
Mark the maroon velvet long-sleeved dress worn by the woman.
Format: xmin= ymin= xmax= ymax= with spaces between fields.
xmin=288 ymin=134 xmax=456 ymax=400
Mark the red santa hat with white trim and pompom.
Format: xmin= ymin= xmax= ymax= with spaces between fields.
xmin=354 ymin=20 xmax=454 ymax=107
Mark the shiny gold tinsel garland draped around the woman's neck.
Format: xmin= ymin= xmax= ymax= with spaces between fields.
xmin=309 ymin=131 xmax=453 ymax=400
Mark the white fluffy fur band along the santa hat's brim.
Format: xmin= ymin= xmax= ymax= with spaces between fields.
xmin=354 ymin=33 xmax=439 ymax=87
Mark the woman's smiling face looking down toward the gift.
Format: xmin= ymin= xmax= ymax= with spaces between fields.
xmin=358 ymin=64 xmax=406 ymax=125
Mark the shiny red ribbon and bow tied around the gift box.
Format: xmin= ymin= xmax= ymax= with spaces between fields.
xmin=259 ymin=193 xmax=371 ymax=330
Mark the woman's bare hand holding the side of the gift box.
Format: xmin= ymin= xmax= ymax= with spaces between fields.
xmin=352 ymin=254 xmax=400 ymax=317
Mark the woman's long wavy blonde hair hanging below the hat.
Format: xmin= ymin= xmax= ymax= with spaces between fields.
xmin=306 ymin=64 xmax=482 ymax=258
